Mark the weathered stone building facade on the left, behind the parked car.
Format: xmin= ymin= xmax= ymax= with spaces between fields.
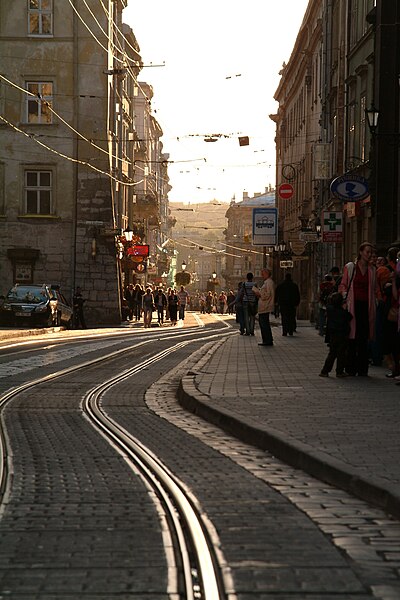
xmin=0 ymin=0 xmax=168 ymax=325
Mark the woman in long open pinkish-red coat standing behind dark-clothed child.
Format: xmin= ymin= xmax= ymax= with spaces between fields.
xmin=339 ymin=242 xmax=381 ymax=376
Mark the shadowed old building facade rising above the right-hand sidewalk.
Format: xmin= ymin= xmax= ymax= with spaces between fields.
xmin=272 ymin=0 xmax=392 ymax=318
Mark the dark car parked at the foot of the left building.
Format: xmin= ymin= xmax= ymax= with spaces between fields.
xmin=0 ymin=283 xmax=73 ymax=328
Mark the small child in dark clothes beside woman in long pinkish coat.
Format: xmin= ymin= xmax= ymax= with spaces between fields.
xmin=319 ymin=292 xmax=353 ymax=377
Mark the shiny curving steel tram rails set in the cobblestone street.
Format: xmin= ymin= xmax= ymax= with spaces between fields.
xmin=0 ymin=329 xmax=232 ymax=600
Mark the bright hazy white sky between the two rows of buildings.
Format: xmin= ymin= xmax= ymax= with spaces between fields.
xmin=123 ymin=0 xmax=308 ymax=203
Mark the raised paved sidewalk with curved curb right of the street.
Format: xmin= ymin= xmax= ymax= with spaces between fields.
xmin=179 ymin=320 xmax=400 ymax=517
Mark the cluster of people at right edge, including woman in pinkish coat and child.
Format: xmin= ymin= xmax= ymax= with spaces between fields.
xmin=319 ymin=242 xmax=400 ymax=384
